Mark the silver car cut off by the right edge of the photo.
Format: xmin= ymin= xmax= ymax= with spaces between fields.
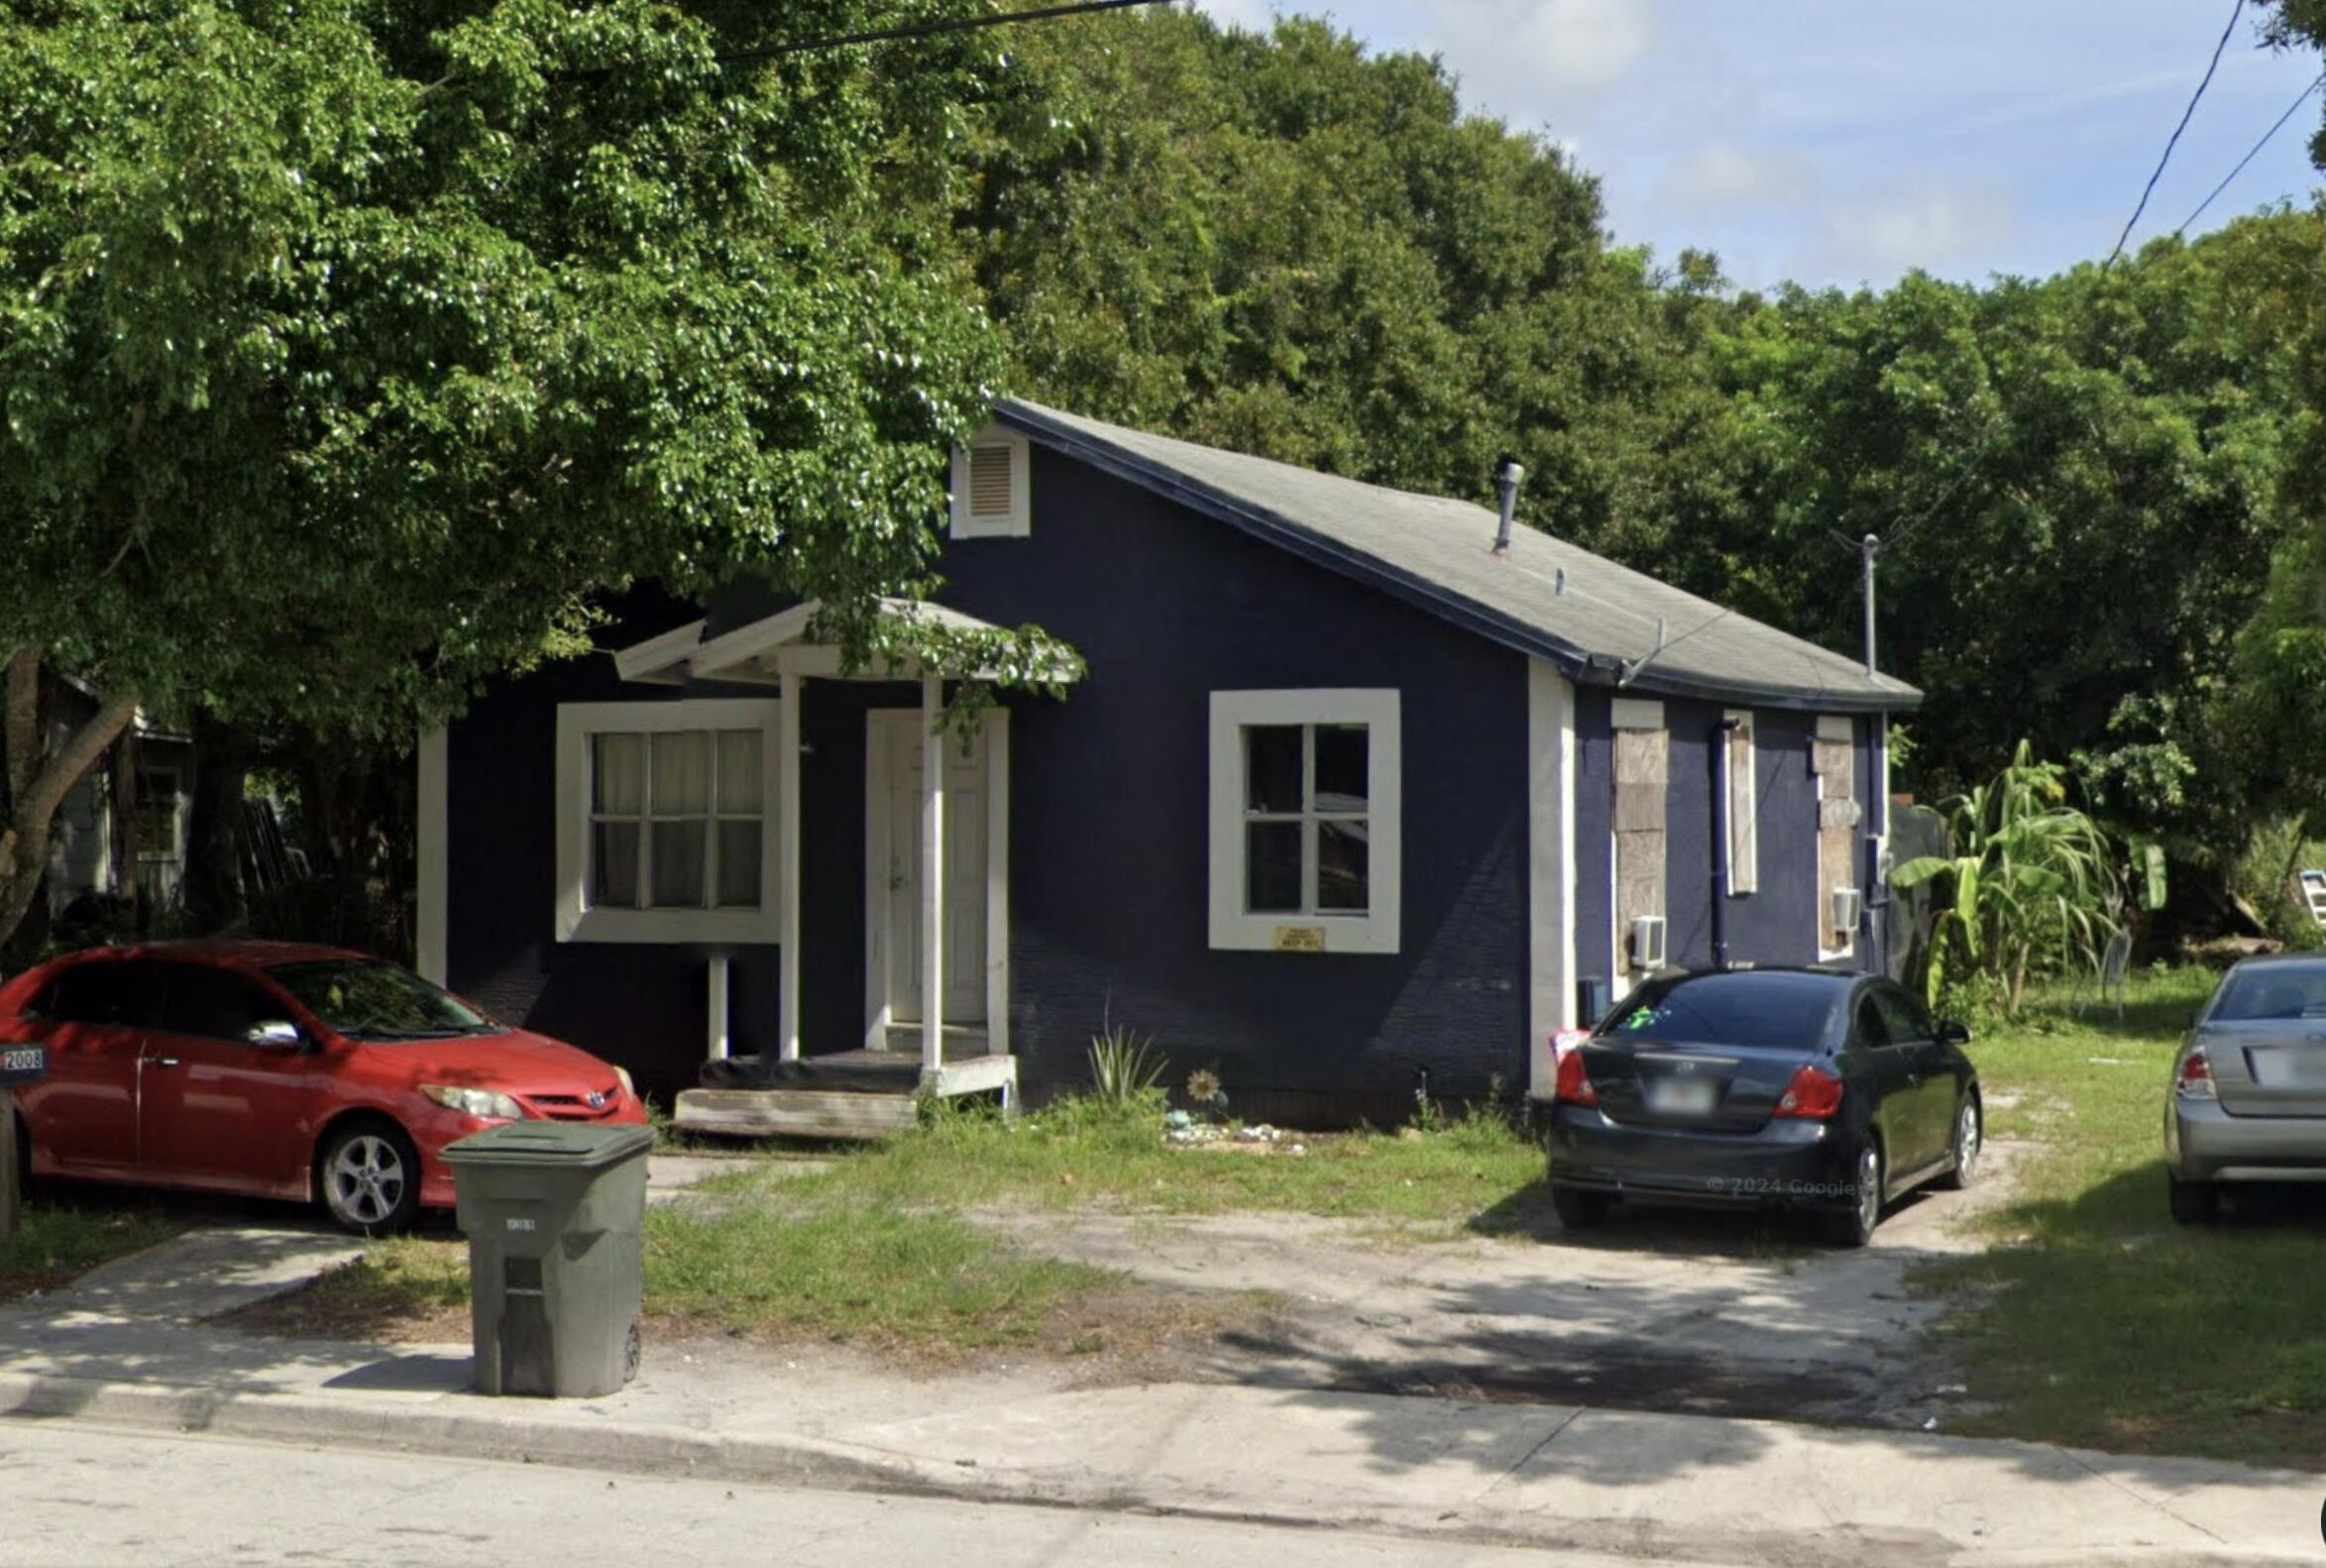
xmin=2165 ymin=953 xmax=2326 ymax=1224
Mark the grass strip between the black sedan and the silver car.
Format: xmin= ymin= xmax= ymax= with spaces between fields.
xmin=1922 ymin=970 xmax=2326 ymax=1468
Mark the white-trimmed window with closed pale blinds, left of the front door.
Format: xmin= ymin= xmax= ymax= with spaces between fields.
xmin=556 ymin=698 xmax=784 ymax=943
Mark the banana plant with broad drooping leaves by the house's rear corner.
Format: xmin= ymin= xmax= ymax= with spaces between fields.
xmin=1891 ymin=739 xmax=2121 ymax=1017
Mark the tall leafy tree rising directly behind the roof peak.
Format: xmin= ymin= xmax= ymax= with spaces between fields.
xmin=958 ymin=14 xmax=1710 ymax=537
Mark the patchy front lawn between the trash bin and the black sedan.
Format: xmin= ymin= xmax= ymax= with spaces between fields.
xmin=247 ymin=1105 xmax=1542 ymax=1354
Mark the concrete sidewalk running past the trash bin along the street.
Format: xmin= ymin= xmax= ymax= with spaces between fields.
xmin=0 ymin=1228 xmax=2326 ymax=1568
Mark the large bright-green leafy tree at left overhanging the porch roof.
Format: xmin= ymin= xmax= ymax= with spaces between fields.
xmin=0 ymin=0 xmax=1040 ymax=938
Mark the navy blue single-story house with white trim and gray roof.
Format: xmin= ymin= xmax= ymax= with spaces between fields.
xmin=418 ymin=402 xmax=1919 ymax=1124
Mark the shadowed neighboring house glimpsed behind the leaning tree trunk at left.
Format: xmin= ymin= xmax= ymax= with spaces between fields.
xmin=47 ymin=682 xmax=193 ymax=917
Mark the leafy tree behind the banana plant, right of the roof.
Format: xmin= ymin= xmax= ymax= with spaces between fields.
xmin=1630 ymin=214 xmax=2307 ymax=853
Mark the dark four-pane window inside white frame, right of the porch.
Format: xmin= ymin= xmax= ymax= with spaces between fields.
xmin=1245 ymin=724 xmax=1373 ymax=914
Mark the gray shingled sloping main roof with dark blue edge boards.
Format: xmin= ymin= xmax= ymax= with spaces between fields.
xmin=993 ymin=400 xmax=1922 ymax=712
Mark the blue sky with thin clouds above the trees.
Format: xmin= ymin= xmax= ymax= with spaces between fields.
xmin=1195 ymin=0 xmax=2321 ymax=286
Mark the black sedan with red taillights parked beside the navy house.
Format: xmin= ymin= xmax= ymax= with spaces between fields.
xmin=1549 ymin=970 xmax=1984 ymax=1247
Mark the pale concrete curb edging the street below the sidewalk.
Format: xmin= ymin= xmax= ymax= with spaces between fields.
xmin=0 ymin=1373 xmax=2312 ymax=1568
